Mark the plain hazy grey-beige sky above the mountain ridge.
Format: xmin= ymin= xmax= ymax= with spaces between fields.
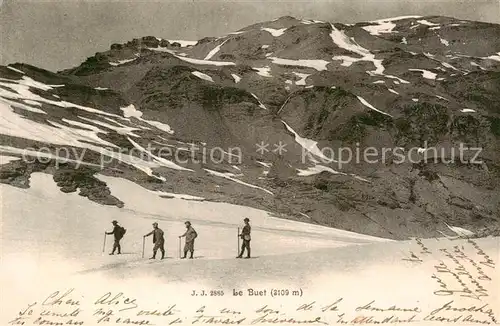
xmin=0 ymin=0 xmax=500 ymax=71
